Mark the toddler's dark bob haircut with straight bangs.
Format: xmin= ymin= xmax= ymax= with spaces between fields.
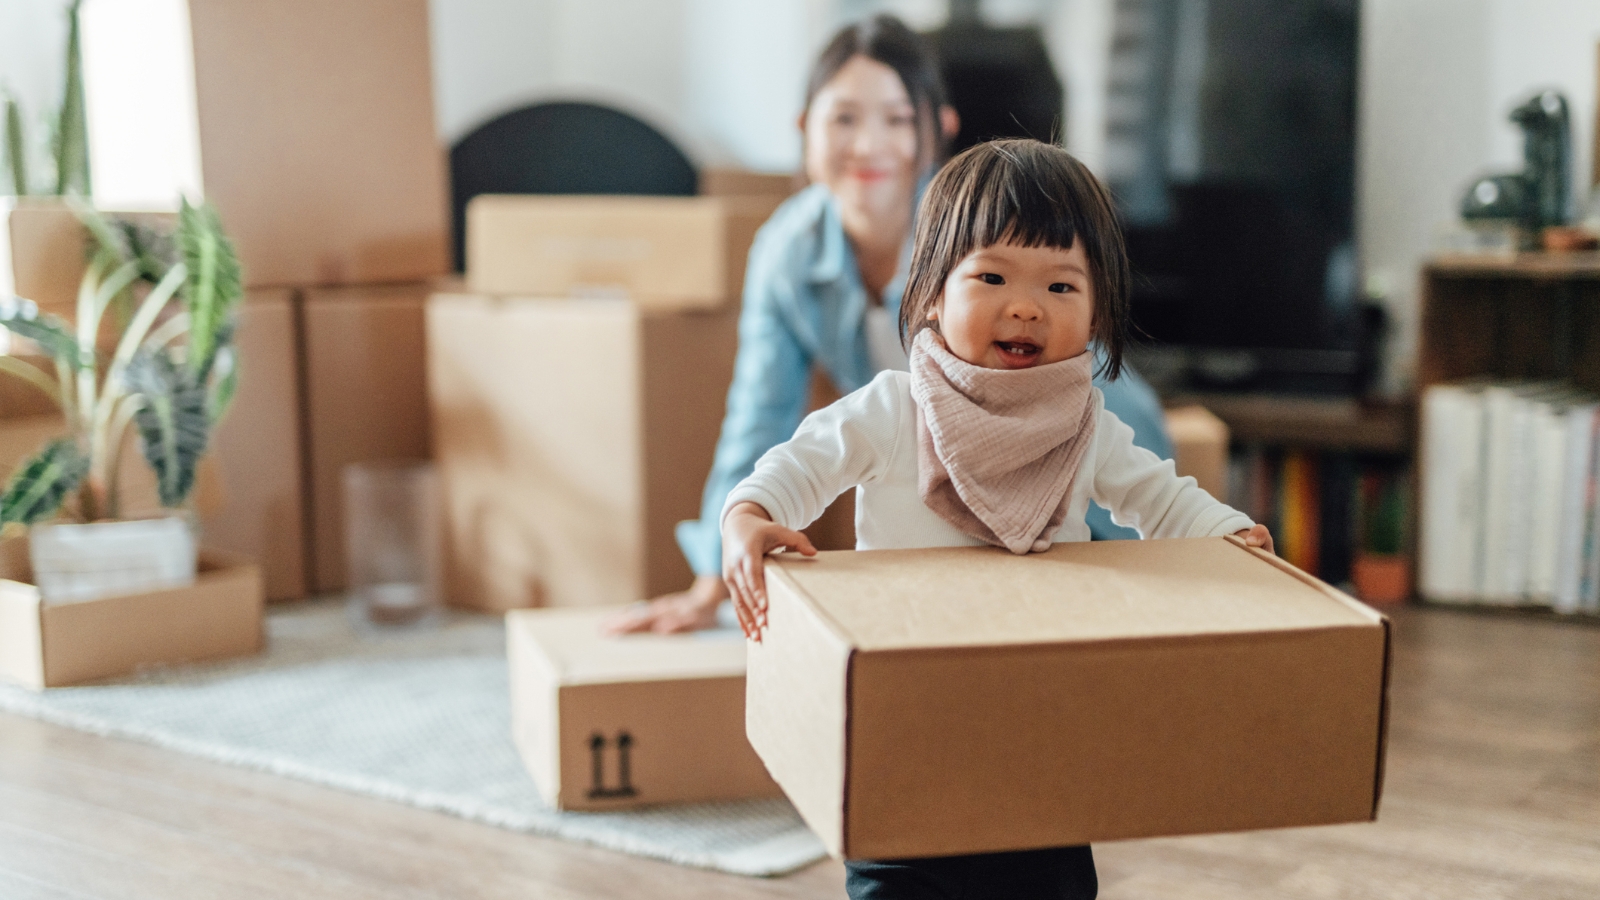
xmin=899 ymin=139 xmax=1128 ymax=380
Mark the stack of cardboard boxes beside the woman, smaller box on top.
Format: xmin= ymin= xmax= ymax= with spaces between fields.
xmin=427 ymin=195 xmax=779 ymax=610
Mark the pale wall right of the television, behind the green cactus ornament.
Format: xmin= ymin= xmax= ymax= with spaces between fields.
xmin=1357 ymin=0 xmax=1600 ymax=391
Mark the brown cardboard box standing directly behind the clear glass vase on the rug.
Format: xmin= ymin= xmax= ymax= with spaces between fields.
xmin=302 ymin=283 xmax=429 ymax=594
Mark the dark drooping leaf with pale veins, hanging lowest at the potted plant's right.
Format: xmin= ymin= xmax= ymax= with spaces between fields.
xmin=123 ymin=351 xmax=211 ymax=508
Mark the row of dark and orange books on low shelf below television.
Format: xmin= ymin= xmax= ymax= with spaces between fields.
xmin=1229 ymin=445 xmax=1408 ymax=585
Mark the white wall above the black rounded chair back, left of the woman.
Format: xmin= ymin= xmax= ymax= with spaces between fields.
xmin=430 ymin=0 xmax=834 ymax=171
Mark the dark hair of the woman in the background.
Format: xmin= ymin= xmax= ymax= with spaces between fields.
xmin=805 ymin=14 xmax=947 ymax=165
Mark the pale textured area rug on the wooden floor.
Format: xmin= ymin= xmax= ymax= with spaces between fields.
xmin=0 ymin=601 xmax=824 ymax=876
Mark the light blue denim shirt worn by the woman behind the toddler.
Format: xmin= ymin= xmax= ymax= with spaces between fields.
xmin=677 ymin=184 xmax=1173 ymax=575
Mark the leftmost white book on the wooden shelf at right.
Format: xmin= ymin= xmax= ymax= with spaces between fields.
xmin=1418 ymin=383 xmax=1485 ymax=602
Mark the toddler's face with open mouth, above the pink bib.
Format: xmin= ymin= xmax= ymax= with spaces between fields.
xmin=928 ymin=240 xmax=1094 ymax=368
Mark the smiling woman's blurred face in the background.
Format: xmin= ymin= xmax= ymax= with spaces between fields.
xmin=800 ymin=56 xmax=918 ymax=218
